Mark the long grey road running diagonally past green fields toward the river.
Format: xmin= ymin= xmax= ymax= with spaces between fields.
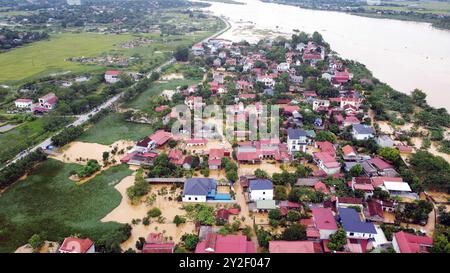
xmin=2 ymin=20 xmax=230 ymax=169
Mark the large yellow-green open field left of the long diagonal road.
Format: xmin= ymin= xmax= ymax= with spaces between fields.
xmin=0 ymin=33 xmax=132 ymax=84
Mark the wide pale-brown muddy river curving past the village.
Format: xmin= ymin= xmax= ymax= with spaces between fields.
xmin=202 ymin=0 xmax=450 ymax=110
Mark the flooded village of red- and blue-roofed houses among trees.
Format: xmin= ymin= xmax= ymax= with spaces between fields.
xmin=10 ymin=35 xmax=446 ymax=253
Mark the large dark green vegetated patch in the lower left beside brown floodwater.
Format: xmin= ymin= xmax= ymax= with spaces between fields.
xmin=0 ymin=159 xmax=132 ymax=252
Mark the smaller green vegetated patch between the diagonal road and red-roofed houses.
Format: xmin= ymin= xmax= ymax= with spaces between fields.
xmin=77 ymin=113 xmax=154 ymax=145
